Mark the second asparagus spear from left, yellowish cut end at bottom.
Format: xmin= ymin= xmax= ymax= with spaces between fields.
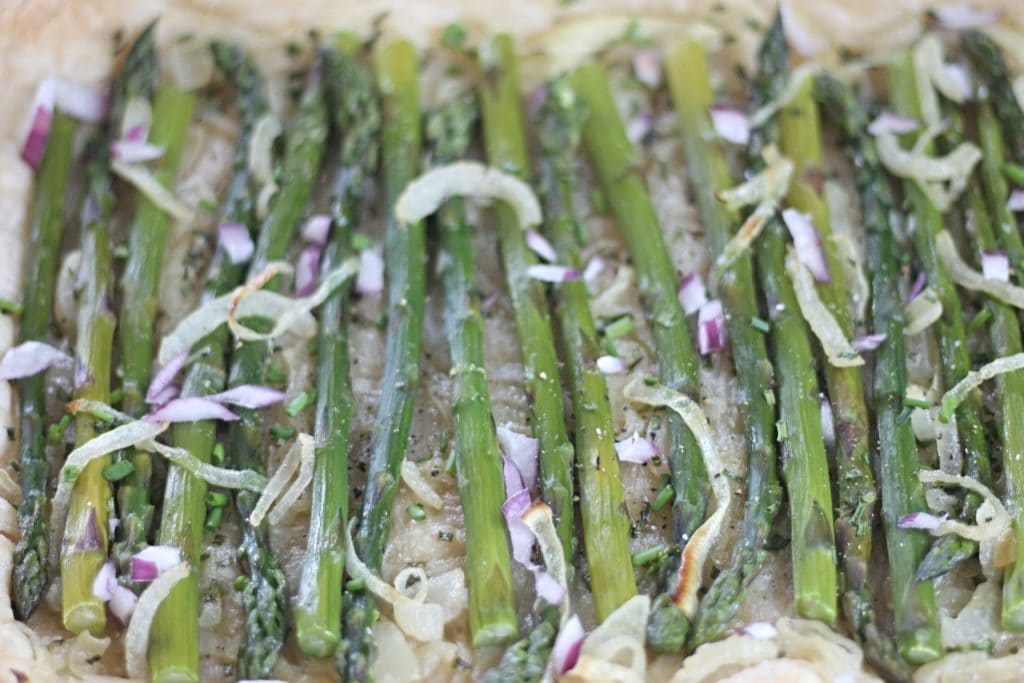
xmin=60 ymin=25 xmax=158 ymax=635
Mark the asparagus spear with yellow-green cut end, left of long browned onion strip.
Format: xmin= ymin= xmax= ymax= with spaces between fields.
xmin=541 ymin=80 xmax=637 ymax=622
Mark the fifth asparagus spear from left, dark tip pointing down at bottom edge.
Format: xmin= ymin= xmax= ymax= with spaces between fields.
xmin=228 ymin=58 xmax=328 ymax=679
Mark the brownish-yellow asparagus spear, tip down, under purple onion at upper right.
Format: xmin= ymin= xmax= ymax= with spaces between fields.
xmin=779 ymin=81 xmax=877 ymax=634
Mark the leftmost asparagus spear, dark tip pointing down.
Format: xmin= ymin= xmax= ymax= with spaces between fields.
xmin=13 ymin=110 xmax=77 ymax=620
